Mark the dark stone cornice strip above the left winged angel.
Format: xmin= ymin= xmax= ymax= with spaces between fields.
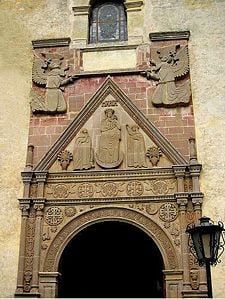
xmin=32 ymin=37 xmax=71 ymax=49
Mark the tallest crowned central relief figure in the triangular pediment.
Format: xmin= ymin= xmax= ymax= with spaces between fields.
xmin=96 ymin=108 xmax=123 ymax=168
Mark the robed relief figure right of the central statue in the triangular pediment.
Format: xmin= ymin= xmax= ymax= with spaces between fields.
xmin=126 ymin=125 xmax=147 ymax=167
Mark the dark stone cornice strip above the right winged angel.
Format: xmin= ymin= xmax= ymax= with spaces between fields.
xmin=149 ymin=31 xmax=190 ymax=42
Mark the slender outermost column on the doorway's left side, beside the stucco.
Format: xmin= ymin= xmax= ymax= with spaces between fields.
xmin=15 ymin=198 xmax=30 ymax=296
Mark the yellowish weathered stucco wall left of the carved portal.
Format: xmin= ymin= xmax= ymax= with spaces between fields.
xmin=0 ymin=0 xmax=70 ymax=297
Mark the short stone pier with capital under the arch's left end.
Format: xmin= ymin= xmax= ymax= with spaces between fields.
xmin=39 ymin=272 xmax=61 ymax=298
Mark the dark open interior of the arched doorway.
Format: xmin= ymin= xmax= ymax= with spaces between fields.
xmin=59 ymin=221 xmax=164 ymax=298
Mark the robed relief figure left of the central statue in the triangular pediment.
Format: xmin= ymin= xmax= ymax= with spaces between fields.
xmin=73 ymin=128 xmax=94 ymax=170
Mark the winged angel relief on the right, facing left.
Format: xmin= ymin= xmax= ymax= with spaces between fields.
xmin=142 ymin=45 xmax=191 ymax=107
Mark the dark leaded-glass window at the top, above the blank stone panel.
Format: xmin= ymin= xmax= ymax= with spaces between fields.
xmin=89 ymin=0 xmax=127 ymax=43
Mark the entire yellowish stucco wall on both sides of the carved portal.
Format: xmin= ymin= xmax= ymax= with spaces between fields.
xmin=0 ymin=0 xmax=225 ymax=297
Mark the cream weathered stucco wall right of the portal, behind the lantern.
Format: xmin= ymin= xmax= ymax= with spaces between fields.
xmin=145 ymin=0 xmax=225 ymax=297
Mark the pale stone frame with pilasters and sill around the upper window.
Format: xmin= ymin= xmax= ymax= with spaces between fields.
xmin=70 ymin=0 xmax=144 ymax=49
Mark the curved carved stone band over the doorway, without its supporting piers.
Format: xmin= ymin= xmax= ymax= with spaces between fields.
xmin=43 ymin=207 xmax=179 ymax=272
